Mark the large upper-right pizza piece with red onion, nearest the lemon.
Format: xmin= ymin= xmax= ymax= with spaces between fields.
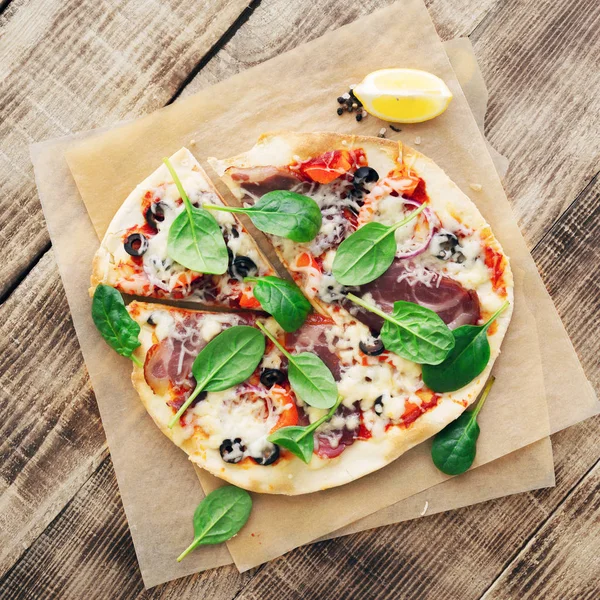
xmin=209 ymin=132 xmax=513 ymax=342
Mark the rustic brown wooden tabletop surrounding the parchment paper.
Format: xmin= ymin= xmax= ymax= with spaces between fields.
xmin=0 ymin=0 xmax=600 ymax=600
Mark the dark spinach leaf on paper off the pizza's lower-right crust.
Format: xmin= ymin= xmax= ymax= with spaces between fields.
xmin=431 ymin=376 xmax=494 ymax=475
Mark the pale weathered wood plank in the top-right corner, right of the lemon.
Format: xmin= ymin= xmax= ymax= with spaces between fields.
xmin=471 ymin=0 xmax=600 ymax=246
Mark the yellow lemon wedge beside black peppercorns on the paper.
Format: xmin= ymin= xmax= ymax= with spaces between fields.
xmin=353 ymin=69 xmax=452 ymax=123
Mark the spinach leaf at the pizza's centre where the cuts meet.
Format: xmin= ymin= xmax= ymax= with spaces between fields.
xmin=244 ymin=275 xmax=311 ymax=332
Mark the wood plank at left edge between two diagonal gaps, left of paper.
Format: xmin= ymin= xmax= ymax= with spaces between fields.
xmin=0 ymin=251 xmax=107 ymax=574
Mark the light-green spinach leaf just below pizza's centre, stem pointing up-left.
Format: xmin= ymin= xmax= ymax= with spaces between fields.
xmin=256 ymin=321 xmax=338 ymax=408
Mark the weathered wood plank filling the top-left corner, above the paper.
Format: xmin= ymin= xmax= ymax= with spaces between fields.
xmin=0 ymin=0 xmax=251 ymax=298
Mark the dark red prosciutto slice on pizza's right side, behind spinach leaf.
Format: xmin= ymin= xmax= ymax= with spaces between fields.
xmin=344 ymin=258 xmax=480 ymax=332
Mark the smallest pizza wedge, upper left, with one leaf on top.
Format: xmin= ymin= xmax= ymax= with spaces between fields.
xmin=91 ymin=148 xmax=274 ymax=309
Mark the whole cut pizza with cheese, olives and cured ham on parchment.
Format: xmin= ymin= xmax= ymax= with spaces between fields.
xmin=95 ymin=133 xmax=513 ymax=495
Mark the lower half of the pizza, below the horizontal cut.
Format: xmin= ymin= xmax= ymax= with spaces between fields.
xmin=128 ymin=302 xmax=502 ymax=495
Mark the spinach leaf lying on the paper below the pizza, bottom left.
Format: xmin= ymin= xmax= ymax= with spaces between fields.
xmin=177 ymin=485 xmax=252 ymax=562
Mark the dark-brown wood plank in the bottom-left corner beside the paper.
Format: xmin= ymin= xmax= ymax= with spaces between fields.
xmin=0 ymin=458 xmax=142 ymax=598
